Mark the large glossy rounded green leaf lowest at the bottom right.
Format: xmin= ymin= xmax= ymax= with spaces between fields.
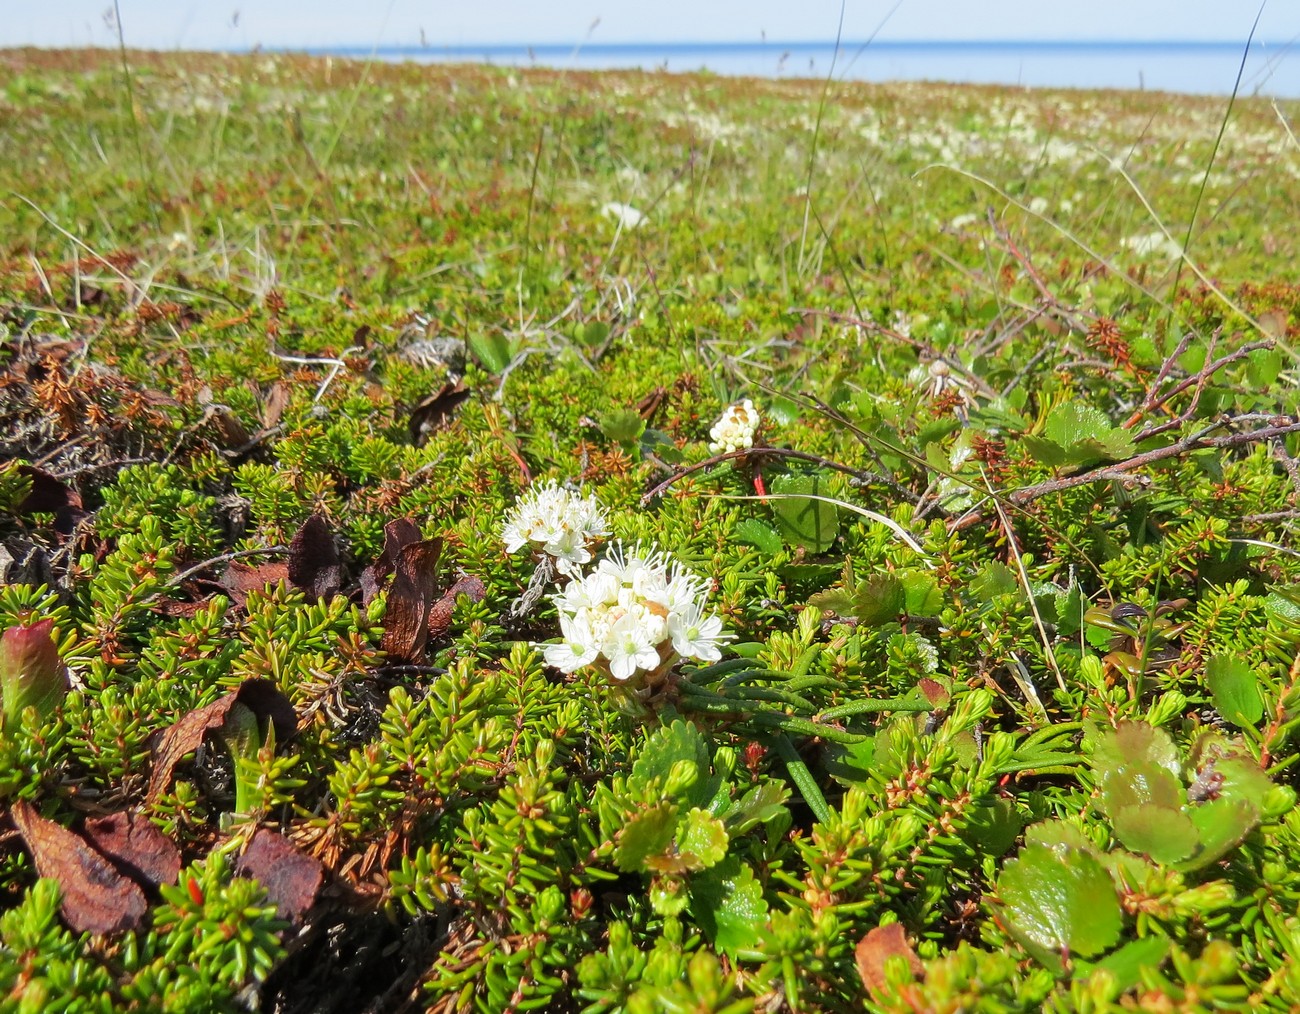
xmin=997 ymin=845 xmax=1122 ymax=959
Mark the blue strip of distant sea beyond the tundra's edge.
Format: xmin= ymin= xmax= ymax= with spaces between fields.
xmin=312 ymin=40 xmax=1300 ymax=99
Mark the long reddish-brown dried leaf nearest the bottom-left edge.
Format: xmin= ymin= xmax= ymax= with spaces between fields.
xmin=12 ymin=800 xmax=148 ymax=933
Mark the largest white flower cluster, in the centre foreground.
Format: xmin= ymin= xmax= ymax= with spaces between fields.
xmin=543 ymin=546 xmax=729 ymax=681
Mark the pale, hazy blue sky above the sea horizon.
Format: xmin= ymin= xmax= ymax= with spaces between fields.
xmin=10 ymin=0 xmax=1300 ymax=49
